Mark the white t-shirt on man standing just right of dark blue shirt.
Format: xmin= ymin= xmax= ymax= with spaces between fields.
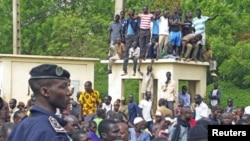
xmin=139 ymin=99 xmax=152 ymax=122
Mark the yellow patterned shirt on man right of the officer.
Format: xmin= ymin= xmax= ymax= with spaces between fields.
xmin=78 ymin=90 xmax=102 ymax=116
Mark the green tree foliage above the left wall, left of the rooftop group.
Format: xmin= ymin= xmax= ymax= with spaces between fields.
xmin=0 ymin=0 xmax=114 ymax=57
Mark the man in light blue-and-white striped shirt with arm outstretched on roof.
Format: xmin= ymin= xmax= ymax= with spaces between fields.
xmin=192 ymin=9 xmax=218 ymax=60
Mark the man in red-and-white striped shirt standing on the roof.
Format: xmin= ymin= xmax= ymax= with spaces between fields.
xmin=137 ymin=6 xmax=154 ymax=72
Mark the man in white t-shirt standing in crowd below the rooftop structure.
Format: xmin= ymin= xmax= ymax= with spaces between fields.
xmin=139 ymin=91 xmax=153 ymax=133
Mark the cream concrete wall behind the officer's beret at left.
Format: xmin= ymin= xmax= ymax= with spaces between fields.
xmin=0 ymin=54 xmax=99 ymax=102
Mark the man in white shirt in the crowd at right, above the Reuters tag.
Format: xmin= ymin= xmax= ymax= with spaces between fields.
xmin=194 ymin=94 xmax=209 ymax=121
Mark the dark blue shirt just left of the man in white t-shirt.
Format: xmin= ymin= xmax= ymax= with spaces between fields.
xmin=128 ymin=102 xmax=140 ymax=124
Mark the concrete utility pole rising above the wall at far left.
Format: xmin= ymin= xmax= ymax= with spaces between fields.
xmin=12 ymin=0 xmax=21 ymax=54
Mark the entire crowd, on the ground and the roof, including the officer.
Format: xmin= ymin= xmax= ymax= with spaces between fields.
xmin=0 ymin=6 xmax=247 ymax=141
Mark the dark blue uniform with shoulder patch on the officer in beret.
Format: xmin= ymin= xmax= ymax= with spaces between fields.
xmin=7 ymin=106 xmax=71 ymax=141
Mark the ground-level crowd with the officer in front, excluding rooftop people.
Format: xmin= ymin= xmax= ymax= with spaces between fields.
xmin=0 ymin=64 xmax=250 ymax=141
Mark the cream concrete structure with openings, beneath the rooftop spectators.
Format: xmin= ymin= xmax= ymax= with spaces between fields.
xmin=101 ymin=59 xmax=208 ymax=107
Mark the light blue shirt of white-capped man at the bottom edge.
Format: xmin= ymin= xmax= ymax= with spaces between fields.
xmin=129 ymin=128 xmax=150 ymax=141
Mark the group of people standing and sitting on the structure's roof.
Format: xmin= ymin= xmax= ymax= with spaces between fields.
xmin=107 ymin=6 xmax=217 ymax=76
